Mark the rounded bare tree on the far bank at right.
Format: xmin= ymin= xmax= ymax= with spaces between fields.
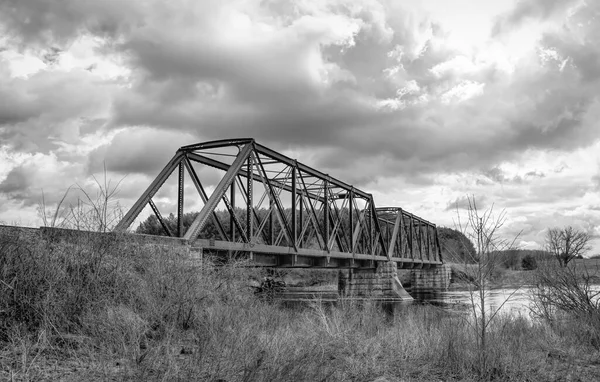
xmin=546 ymin=226 xmax=591 ymax=267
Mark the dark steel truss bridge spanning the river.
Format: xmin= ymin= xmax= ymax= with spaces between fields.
xmin=115 ymin=139 xmax=442 ymax=268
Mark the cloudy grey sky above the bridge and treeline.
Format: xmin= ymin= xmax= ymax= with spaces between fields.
xmin=0 ymin=0 xmax=600 ymax=254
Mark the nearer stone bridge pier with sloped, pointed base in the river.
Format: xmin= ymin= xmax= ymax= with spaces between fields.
xmin=338 ymin=261 xmax=412 ymax=301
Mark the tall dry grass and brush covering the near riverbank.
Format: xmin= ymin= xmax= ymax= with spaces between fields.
xmin=0 ymin=228 xmax=600 ymax=381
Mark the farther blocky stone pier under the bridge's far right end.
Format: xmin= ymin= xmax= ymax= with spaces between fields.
xmin=410 ymin=264 xmax=451 ymax=300
